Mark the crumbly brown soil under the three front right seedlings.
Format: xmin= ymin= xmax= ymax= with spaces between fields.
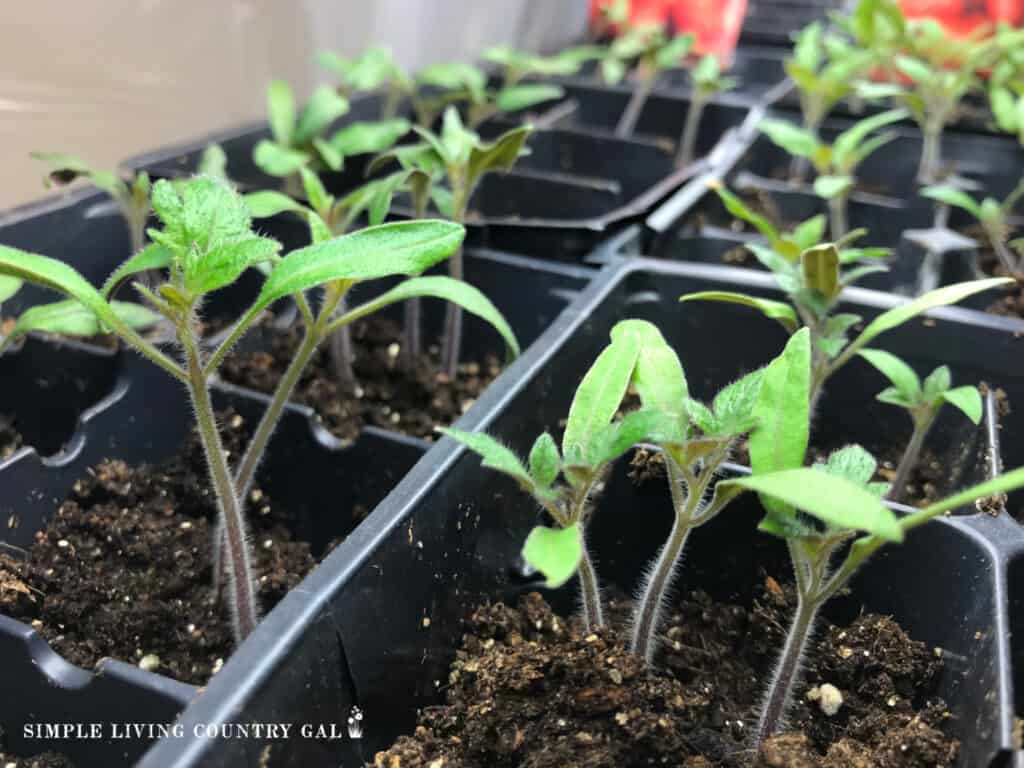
xmin=374 ymin=593 xmax=958 ymax=768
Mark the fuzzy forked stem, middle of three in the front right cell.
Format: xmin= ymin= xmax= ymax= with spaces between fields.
xmin=630 ymin=452 xmax=712 ymax=665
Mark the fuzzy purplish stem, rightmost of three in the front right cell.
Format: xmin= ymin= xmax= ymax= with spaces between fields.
xmin=755 ymin=541 xmax=823 ymax=749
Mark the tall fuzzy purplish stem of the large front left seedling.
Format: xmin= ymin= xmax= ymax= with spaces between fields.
xmin=178 ymin=321 xmax=259 ymax=644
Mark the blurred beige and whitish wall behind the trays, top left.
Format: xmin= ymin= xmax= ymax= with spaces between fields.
xmin=0 ymin=0 xmax=588 ymax=209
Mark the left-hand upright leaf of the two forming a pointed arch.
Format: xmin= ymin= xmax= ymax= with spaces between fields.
xmin=562 ymin=336 xmax=640 ymax=465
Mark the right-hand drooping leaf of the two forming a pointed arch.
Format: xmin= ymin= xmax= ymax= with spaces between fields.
xmin=611 ymin=319 xmax=689 ymax=443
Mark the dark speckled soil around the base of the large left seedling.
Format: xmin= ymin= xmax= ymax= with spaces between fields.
xmin=0 ymin=414 xmax=315 ymax=685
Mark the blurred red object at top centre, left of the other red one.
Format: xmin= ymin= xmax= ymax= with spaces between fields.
xmin=590 ymin=0 xmax=746 ymax=61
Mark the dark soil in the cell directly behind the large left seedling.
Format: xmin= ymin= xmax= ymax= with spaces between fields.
xmin=219 ymin=317 xmax=501 ymax=440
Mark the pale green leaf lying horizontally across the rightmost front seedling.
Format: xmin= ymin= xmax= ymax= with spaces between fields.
xmin=719 ymin=467 xmax=903 ymax=542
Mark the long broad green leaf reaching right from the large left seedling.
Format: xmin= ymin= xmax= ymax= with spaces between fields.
xmin=249 ymin=219 xmax=466 ymax=316
